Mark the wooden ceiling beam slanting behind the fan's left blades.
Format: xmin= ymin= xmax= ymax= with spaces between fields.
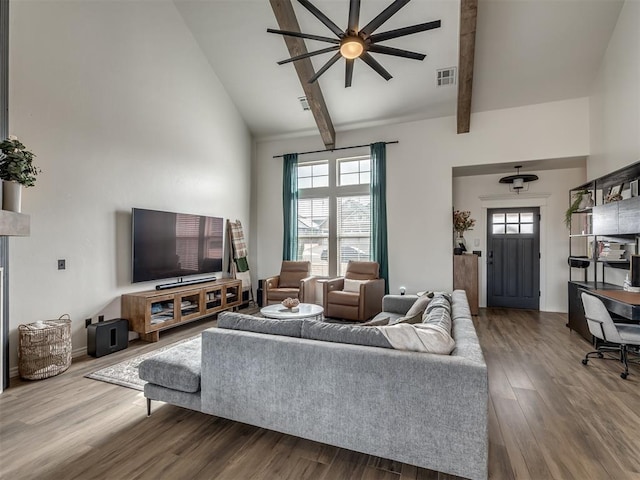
xmin=269 ymin=0 xmax=336 ymax=149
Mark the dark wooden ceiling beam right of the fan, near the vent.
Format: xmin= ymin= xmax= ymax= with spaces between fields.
xmin=457 ymin=0 xmax=478 ymax=133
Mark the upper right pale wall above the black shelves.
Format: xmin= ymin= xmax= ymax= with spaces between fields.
xmin=587 ymin=0 xmax=640 ymax=179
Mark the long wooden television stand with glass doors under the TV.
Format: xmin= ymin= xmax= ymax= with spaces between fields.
xmin=122 ymin=278 xmax=242 ymax=342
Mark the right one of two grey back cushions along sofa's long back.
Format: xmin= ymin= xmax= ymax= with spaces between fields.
xmin=302 ymin=320 xmax=392 ymax=348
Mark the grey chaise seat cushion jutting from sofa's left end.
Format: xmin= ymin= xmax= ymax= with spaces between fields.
xmin=138 ymin=337 xmax=202 ymax=393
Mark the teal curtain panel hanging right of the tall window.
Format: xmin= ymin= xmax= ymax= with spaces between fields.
xmin=371 ymin=142 xmax=389 ymax=293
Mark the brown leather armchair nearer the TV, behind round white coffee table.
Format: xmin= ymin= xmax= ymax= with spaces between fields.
xmin=263 ymin=260 xmax=315 ymax=305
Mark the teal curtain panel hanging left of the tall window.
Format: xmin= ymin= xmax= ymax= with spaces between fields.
xmin=282 ymin=153 xmax=298 ymax=260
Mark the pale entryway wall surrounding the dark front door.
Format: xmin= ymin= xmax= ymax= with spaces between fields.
xmin=453 ymin=168 xmax=586 ymax=312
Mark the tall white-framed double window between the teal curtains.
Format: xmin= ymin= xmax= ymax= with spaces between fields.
xmin=298 ymin=156 xmax=371 ymax=276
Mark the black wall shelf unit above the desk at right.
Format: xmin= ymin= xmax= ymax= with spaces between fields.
xmin=567 ymin=162 xmax=640 ymax=341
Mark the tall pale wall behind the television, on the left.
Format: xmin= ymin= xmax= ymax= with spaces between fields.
xmin=9 ymin=1 xmax=252 ymax=367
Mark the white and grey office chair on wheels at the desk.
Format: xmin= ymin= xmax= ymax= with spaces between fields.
xmin=581 ymin=292 xmax=640 ymax=379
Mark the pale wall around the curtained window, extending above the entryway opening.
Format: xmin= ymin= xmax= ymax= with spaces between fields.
xmin=250 ymin=98 xmax=589 ymax=298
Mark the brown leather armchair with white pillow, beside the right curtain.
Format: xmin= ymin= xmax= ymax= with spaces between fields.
xmin=322 ymin=261 xmax=384 ymax=322
